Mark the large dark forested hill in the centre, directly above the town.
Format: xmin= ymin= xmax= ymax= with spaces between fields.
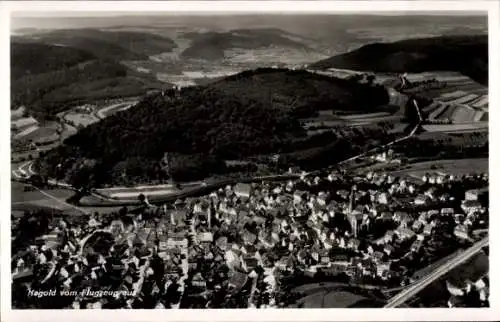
xmin=42 ymin=69 xmax=388 ymax=183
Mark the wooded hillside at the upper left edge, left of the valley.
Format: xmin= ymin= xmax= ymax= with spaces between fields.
xmin=11 ymin=41 xmax=167 ymax=119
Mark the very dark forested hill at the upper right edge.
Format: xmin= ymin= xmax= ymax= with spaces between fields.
xmin=310 ymin=35 xmax=488 ymax=84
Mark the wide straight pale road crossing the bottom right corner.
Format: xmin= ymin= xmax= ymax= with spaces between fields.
xmin=384 ymin=237 xmax=489 ymax=308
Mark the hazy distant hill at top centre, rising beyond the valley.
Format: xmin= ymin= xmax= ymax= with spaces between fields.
xmin=182 ymin=29 xmax=312 ymax=60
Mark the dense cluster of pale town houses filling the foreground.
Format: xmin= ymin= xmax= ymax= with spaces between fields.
xmin=13 ymin=167 xmax=488 ymax=308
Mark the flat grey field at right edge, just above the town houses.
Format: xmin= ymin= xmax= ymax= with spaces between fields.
xmin=393 ymin=158 xmax=488 ymax=177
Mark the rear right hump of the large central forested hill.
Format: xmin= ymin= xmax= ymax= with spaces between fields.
xmin=208 ymin=68 xmax=388 ymax=117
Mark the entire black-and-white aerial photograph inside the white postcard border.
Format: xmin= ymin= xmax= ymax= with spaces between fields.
xmin=10 ymin=7 xmax=490 ymax=310
